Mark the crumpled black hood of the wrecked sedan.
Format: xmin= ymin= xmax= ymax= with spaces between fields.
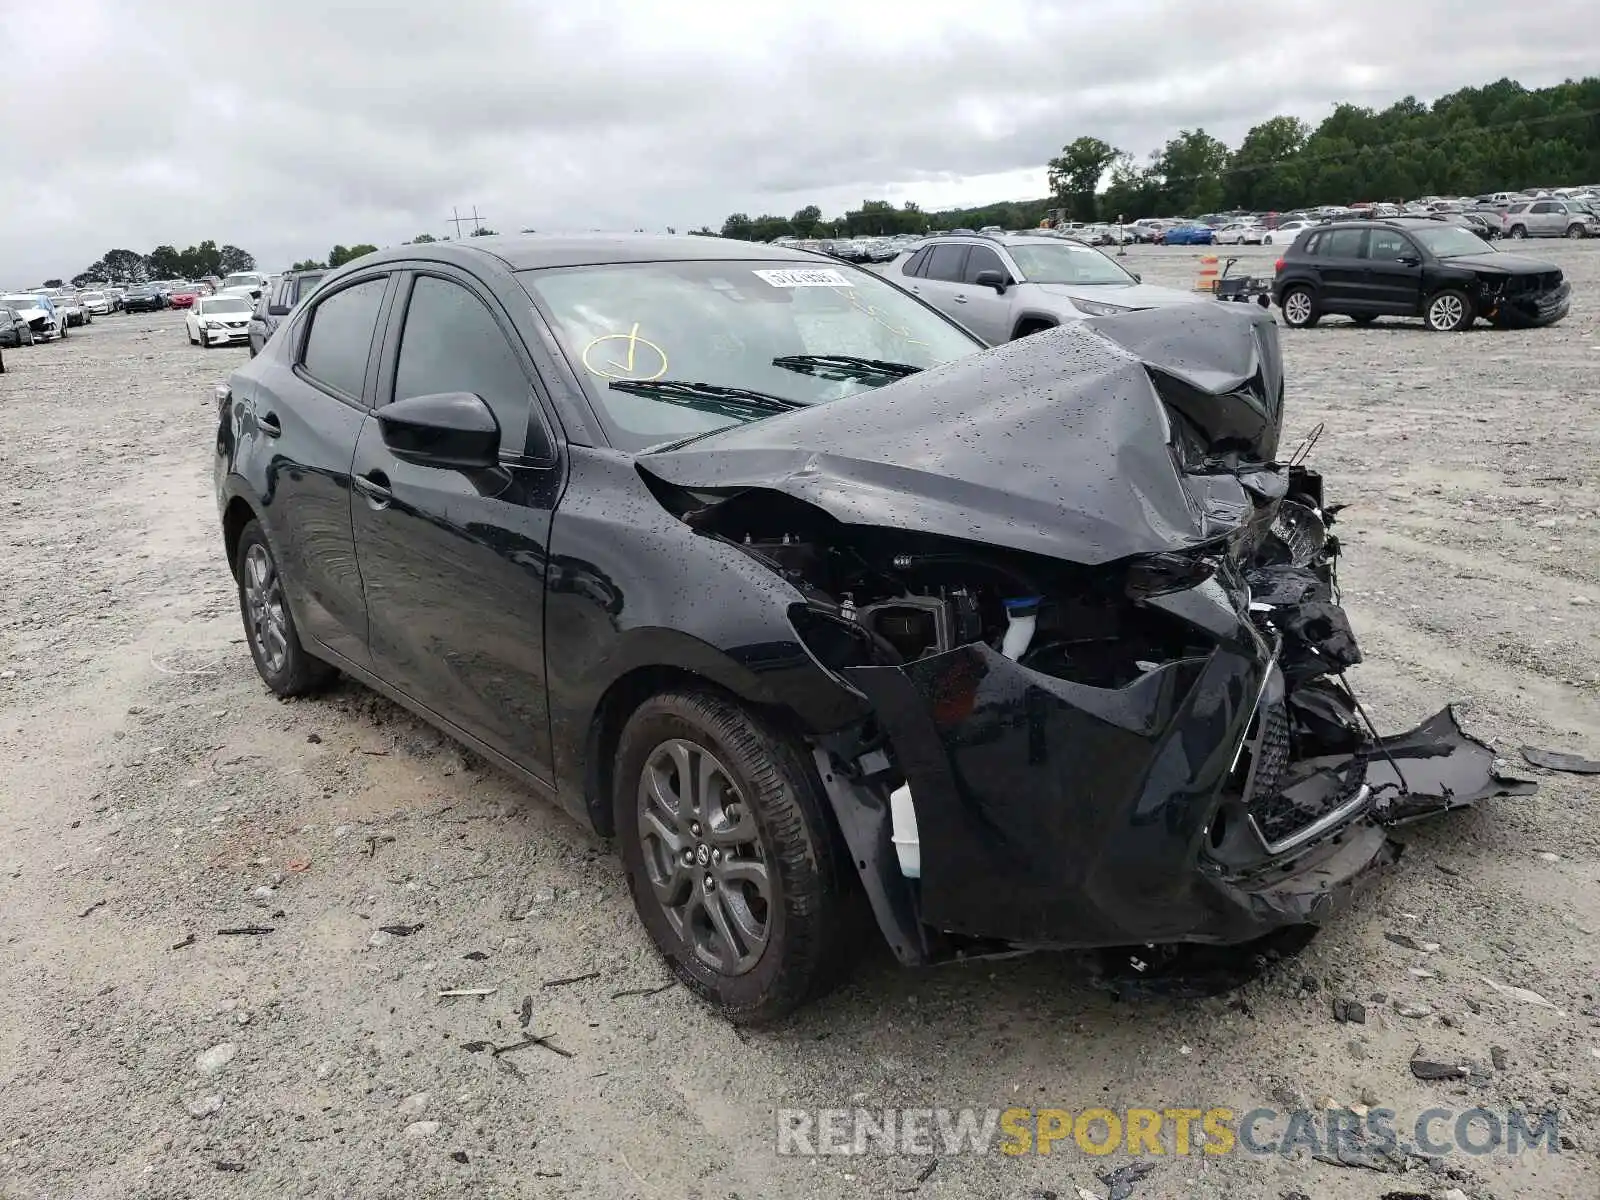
xmin=638 ymin=304 xmax=1283 ymax=565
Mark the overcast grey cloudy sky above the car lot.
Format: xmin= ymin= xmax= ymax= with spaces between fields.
xmin=0 ymin=0 xmax=1600 ymax=285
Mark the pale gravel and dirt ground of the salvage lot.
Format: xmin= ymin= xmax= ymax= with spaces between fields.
xmin=0 ymin=243 xmax=1600 ymax=1200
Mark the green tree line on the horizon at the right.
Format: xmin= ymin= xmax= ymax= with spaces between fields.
xmin=713 ymin=77 xmax=1600 ymax=242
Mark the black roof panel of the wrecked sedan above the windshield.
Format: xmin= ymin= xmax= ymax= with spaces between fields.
xmin=360 ymin=234 xmax=825 ymax=270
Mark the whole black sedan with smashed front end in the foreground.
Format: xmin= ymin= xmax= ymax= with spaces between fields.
xmin=216 ymin=237 xmax=1518 ymax=1021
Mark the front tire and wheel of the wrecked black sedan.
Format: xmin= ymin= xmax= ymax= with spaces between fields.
xmin=613 ymin=691 xmax=850 ymax=1024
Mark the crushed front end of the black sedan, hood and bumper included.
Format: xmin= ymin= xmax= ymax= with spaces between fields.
xmin=642 ymin=310 xmax=1528 ymax=962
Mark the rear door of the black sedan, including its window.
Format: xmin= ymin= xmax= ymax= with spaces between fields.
xmin=234 ymin=269 xmax=394 ymax=666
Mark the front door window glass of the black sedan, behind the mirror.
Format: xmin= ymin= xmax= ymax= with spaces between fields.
xmin=395 ymin=275 xmax=547 ymax=454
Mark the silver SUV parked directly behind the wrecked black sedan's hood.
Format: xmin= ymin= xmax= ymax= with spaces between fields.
xmin=894 ymin=234 xmax=1203 ymax=344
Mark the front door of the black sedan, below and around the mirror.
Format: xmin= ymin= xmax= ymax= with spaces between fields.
xmin=352 ymin=266 xmax=562 ymax=779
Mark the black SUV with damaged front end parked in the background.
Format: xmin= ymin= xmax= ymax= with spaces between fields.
xmin=1272 ymin=218 xmax=1573 ymax=333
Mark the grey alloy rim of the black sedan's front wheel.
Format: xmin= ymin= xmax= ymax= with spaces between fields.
xmin=637 ymin=738 xmax=773 ymax=976
